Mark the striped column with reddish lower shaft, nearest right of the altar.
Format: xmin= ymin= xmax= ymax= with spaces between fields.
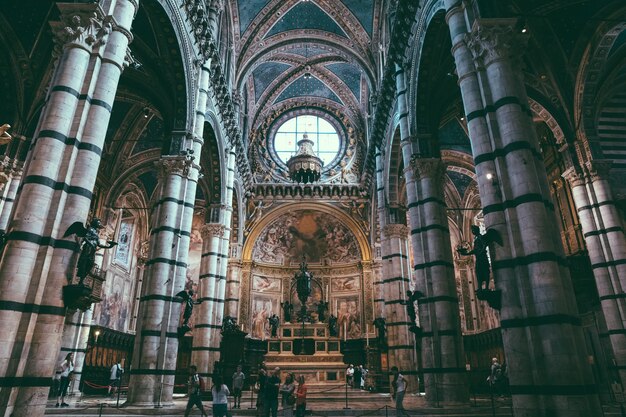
xmin=382 ymin=224 xmax=418 ymax=391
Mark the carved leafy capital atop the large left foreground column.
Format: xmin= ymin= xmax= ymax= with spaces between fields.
xmin=50 ymin=3 xmax=113 ymax=55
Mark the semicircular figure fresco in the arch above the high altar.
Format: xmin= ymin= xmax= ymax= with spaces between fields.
xmin=252 ymin=210 xmax=361 ymax=263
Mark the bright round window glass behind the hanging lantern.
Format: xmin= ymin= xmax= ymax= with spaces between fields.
xmin=274 ymin=115 xmax=340 ymax=167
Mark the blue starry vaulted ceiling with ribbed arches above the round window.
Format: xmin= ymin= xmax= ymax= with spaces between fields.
xmin=229 ymin=0 xmax=382 ymax=129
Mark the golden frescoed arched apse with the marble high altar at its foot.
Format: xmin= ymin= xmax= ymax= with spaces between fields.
xmin=239 ymin=206 xmax=375 ymax=384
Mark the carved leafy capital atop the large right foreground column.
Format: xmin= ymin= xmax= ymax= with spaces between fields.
xmin=465 ymin=19 xmax=528 ymax=67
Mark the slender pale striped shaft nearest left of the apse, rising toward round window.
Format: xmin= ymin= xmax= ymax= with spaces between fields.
xmin=209 ymin=146 xmax=236 ymax=364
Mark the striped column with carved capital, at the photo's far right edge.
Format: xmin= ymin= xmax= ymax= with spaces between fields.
xmin=563 ymin=161 xmax=626 ymax=382
